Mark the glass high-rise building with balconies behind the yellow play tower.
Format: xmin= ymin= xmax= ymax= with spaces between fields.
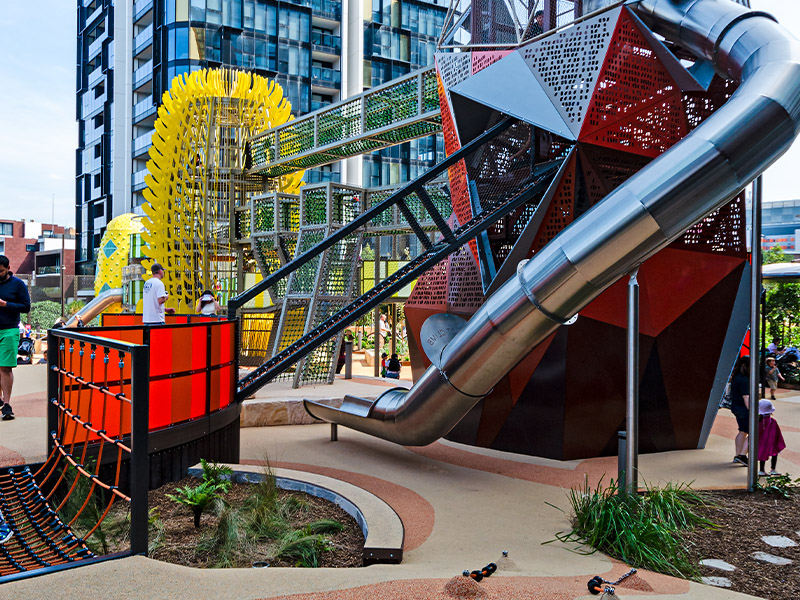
xmin=75 ymin=0 xmax=447 ymax=275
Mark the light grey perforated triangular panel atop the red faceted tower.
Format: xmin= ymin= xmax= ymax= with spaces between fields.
xmin=518 ymin=9 xmax=621 ymax=136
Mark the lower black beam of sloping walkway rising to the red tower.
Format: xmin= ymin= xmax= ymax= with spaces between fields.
xmin=236 ymin=155 xmax=563 ymax=401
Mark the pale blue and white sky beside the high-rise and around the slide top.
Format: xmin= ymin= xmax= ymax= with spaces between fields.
xmin=0 ymin=0 xmax=800 ymax=226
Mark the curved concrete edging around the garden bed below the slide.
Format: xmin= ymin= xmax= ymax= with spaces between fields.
xmin=189 ymin=464 xmax=405 ymax=565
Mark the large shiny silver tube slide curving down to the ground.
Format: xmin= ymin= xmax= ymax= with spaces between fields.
xmin=305 ymin=0 xmax=800 ymax=446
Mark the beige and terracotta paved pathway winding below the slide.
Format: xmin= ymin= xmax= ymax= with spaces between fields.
xmin=0 ymin=367 xmax=800 ymax=600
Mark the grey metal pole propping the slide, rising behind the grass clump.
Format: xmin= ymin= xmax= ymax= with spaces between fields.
xmin=625 ymin=268 xmax=639 ymax=494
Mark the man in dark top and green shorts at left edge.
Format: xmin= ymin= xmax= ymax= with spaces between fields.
xmin=0 ymin=254 xmax=31 ymax=421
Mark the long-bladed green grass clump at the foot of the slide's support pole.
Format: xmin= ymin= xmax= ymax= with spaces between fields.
xmin=556 ymin=479 xmax=716 ymax=580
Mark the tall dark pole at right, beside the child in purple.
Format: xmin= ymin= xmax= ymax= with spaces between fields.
xmin=747 ymin=175 xmax=763 ymax=492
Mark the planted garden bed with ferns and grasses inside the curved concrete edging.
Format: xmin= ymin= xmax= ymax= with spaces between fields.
xmin=71 ymin=477 xmax=364 ymax=568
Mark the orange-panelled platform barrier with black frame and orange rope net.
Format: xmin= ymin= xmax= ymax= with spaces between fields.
xmin=0 ymin=315 xmax=239 ymax=583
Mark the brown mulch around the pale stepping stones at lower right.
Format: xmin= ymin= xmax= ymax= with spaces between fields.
xmin=686 ymin=490 xmax=800 ymax=600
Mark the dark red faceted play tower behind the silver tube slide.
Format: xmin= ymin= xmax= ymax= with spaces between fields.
xmin=428 ymin=7 xmax=747 ymax=459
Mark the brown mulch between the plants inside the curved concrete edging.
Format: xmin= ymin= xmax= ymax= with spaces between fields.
xmin=149 ymin=477 xmax=364 ymax=568
